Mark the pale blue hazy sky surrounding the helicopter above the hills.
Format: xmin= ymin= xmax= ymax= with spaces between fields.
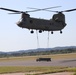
xmin=0 ymin=0 xmax=76 ymax=52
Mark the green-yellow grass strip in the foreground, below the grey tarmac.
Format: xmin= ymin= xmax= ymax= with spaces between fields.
xmin=0 ymin=66 xmax=76 ymax=74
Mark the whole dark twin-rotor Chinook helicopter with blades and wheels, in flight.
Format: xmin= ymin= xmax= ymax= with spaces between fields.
xmin=0 ymin=6 xmax=76 ymax=34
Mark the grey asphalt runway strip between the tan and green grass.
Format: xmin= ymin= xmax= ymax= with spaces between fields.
xmin=0 ymin=59 xmax=76 ymax=67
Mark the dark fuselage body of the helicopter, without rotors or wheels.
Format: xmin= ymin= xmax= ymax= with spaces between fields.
xmin=17 ymin=12 xmax=66 ymax=31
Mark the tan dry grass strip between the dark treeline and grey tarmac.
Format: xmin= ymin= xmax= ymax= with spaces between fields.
xmin=0 ymin=53 xmax=76 ymax=62
